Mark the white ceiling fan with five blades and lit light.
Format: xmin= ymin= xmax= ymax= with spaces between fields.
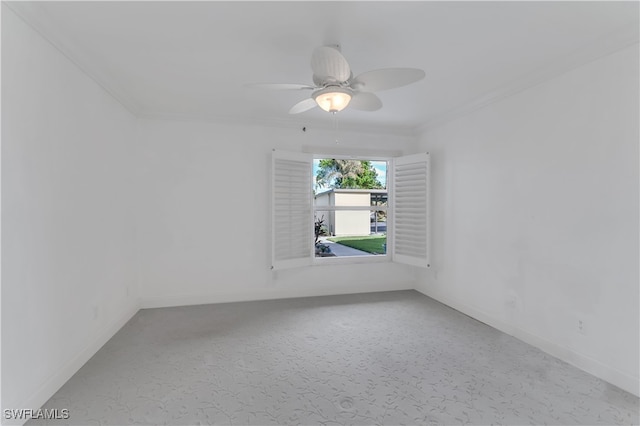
xmin=248 ymin=46 xmax=425 ymax=114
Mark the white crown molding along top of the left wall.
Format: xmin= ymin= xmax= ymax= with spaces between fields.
xmin=2 ymin=1 xmax=140 ymax=116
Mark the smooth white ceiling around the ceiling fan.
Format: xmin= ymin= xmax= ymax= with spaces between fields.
xmin=8 ymin=1 xmax=639 ymax=132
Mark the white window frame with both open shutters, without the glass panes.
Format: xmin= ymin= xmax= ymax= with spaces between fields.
xmin=270 ymin=149 xmax=431 ymax=270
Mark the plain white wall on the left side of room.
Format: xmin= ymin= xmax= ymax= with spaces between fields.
xmin=2 ymin=4 xmax=138 ymax=420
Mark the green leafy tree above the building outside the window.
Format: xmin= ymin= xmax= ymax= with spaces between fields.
xmin=316 ymin=159 xmax=383 ymax=189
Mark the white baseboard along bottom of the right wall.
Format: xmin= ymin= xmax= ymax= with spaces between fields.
xmin=416 ymin=288 xmax=640 ymax=396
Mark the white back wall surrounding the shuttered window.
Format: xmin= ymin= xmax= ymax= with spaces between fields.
xmin=136 ymin=120 xmax=416 ymax=307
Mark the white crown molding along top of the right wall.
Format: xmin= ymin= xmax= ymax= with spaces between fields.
xmin=413 ymin=23 xmax=640 ymax=136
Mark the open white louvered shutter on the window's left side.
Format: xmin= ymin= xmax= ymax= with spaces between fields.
xmin=271 ymin=151 xmax=314 ymax=269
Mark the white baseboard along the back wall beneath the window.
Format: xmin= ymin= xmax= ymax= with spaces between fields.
xmin=140 ymin=282 xmax=415 ymax=309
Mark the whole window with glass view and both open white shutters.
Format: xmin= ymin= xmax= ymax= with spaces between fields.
xmin=271 ymin=151 xmax=430 ymax=269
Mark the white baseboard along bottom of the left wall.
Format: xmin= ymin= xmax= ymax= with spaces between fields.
xmin=2 ymin=301 xmax=139 ymax=426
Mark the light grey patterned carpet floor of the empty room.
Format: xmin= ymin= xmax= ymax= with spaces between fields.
xmin=29 ymin=291 xmax=639 ymax=425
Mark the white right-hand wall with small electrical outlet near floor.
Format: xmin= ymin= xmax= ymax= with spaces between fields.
xmin=419 ymin=45 xmax=640 ymax=395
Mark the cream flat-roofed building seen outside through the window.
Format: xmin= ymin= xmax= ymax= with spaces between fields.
xmin=315 ymin=189 xmax=387 ymax=236
